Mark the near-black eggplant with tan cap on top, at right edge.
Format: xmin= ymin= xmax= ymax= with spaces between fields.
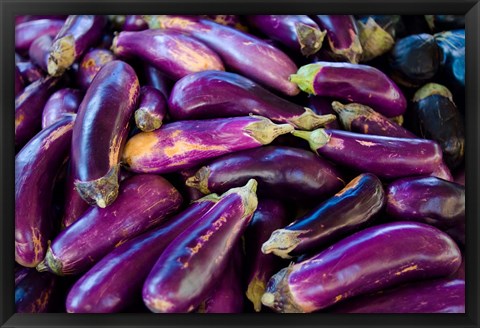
xmin=412 ymin=83 xmax=465 ymax=169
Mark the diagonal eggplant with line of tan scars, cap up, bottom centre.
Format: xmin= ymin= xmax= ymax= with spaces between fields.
xmin=142 ymin=179 xmax=258 ymax=313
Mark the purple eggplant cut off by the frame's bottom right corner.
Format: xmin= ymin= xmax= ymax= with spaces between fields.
xmin=327 ymin=279 xmax=465 ymax=313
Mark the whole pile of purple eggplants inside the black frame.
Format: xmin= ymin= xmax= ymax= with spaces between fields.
xmin=15 ymin=15 xmax=468 ymax=313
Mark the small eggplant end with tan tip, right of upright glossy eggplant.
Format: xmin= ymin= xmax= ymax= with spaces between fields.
xmin=134 ymin=86 xmax=167 ymax=132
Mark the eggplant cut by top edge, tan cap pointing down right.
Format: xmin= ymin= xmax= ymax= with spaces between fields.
xmin=247 ymin=15 xmax=326 ymax=56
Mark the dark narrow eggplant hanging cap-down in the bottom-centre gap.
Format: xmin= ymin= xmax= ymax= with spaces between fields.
xmin=245 ymin=199 xmax=289 ymax=312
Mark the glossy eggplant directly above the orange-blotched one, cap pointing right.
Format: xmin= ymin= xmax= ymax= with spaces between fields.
xmin=168 ymin=71 xmax=335 ymax=130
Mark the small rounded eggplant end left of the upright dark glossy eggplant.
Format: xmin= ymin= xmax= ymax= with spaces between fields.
xmin=42 ymin=88 xmax=83 ymax=129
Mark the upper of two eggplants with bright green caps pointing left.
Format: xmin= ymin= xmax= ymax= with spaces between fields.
xmin=290 ymin=62 xmax=407 ymax=117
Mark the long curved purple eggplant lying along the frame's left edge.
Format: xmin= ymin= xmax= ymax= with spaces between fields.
xmin=15 ymin=116 xmax=75 ymax=267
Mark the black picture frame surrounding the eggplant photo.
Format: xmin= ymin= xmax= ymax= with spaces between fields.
xmin=0 ymin=0 xmax=480 ymax=328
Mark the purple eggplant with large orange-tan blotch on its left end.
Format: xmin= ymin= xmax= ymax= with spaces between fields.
xmin=122 ymin=116 xmax=293 ymax=173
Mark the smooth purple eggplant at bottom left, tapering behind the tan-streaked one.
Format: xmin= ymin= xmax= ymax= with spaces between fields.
xmin=66 ymin=195 xmax=215 ymax=313
